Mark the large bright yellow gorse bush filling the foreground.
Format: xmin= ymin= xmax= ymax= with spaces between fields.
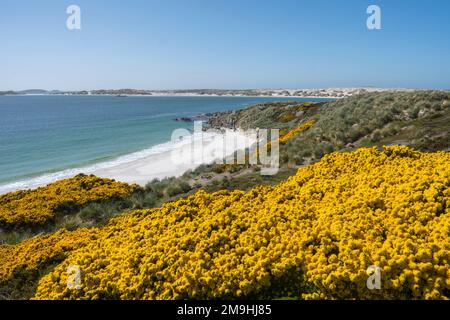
xmin=35 ymin=147 xmax=450 ymax=299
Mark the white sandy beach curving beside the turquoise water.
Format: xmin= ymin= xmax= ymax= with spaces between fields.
xmin=0 ymin=128 xmax=254 ymax=195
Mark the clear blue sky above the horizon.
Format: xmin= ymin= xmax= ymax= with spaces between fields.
xmin=0 ymin=0 xmax=450 ymax=90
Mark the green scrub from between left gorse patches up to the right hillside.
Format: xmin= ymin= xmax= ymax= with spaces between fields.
xmin=4 ymin=91 xmax=450 ymax=243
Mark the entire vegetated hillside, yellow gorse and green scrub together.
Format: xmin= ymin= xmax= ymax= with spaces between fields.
xmin=0 ymin=91 xmax=450 ymax=299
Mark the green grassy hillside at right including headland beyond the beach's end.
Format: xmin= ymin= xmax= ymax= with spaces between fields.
xmin=209 ymin=91 xmax=450 ymax=166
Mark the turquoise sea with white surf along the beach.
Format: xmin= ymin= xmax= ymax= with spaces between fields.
xmin=0 ymin=96 xmax=330 ymax=190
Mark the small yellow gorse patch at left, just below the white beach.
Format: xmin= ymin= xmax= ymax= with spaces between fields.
xmin=0 ymin=175 xmax=138 ymax=225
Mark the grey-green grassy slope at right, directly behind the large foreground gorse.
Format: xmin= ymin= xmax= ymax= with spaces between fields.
xmin=282 ymin=91 xmax=450 ymax=165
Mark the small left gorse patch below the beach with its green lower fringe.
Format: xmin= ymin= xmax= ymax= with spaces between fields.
xmin=0 ymin=174 xmax=140 ymax=241
